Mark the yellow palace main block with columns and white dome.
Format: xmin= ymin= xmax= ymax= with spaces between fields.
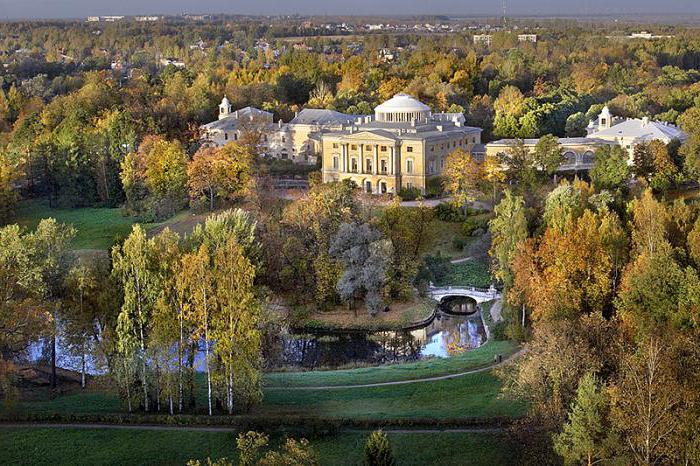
xmin=320 ymin=94 xmax=482 ymax=194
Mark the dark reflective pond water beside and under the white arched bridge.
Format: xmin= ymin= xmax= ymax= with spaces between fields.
xmin=279 ymin=298 xmax=486 ymax=369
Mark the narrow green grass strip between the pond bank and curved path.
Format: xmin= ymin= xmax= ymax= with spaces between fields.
xmin=264 ymin=340 xmax=518 ymax=387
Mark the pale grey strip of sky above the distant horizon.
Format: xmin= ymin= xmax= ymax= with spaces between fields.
xmin=0 ymin=0 xmax=700 ymax=19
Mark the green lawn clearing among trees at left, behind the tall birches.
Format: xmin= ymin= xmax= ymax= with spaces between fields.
xmin=17 ymin=199 xmax=206 ymax=250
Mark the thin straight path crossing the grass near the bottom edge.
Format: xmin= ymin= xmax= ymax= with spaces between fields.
xmin=0 ymin=422 xmax=504 ymax=435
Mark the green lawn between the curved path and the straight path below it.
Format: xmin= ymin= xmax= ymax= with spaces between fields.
xmin=10 ymin=366 xmax=525 ymax=420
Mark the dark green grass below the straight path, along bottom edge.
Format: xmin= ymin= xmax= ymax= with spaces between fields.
xmin=0 ymin=428 xmax=511 ymax=466
